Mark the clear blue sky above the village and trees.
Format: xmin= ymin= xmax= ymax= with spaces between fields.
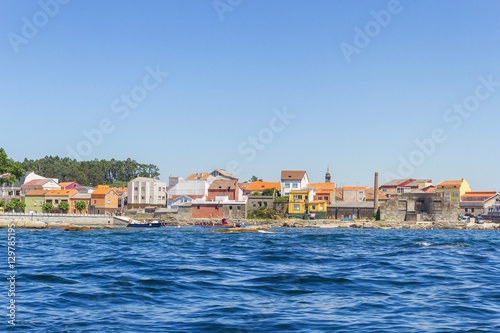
xmin=0 ymin=0 xmax=500 ymax=190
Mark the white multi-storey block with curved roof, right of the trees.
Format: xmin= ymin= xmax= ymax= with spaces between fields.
xmin=127 ymin=177 xmax=167 ymax=209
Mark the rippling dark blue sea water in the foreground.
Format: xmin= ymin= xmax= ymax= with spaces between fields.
xmin=0 ymin=228 xmax=500 ymax=332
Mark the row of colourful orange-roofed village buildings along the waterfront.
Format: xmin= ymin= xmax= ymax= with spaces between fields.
xmin=0 ymin=169 xmax=500 ymax=222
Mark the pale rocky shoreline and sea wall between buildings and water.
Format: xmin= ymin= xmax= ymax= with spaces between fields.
xmin=0 ymin=218 xmax=500 ymax=231
